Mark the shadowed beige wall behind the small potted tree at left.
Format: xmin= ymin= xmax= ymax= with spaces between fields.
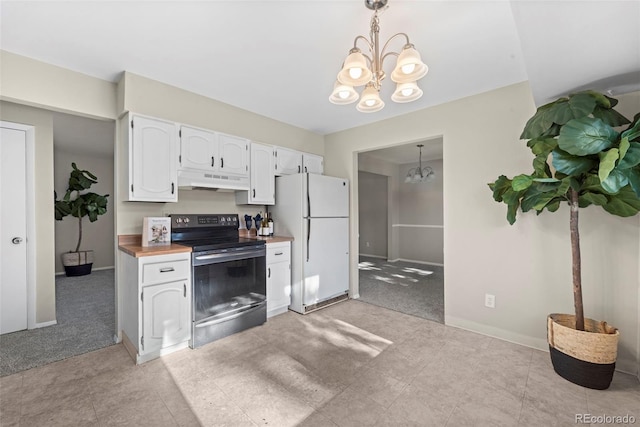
xmin=54 ymin=149 xmax=115 ymax=273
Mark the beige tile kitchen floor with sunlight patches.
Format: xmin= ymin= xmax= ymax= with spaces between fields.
xmin=0 ymin=300 xmax=640 ymax=427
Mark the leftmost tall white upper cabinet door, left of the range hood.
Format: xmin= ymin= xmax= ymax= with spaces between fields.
xmin=129 ymin=116 xmax=178 ymax=202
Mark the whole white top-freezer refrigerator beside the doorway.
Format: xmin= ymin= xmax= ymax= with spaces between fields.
xmin=271 ymin=173 xmax=349 ymax=314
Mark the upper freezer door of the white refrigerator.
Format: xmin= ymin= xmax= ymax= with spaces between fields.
xmin=304 ymin=174 xmax=349 ymax=218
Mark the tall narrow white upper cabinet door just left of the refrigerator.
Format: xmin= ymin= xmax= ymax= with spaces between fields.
xmin=249 ymin=142 xmax=275 ymax=205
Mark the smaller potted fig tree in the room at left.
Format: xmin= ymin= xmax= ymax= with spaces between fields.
xmin=54 ymin=163 xmax=109 ymax=276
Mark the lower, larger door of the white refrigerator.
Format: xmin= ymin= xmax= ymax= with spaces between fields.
xmin=303 ymin=218 xmax=349 ymax=305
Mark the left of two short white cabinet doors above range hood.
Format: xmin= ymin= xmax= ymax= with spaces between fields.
xmin=180 ymin=126 xmax=220 ymax=170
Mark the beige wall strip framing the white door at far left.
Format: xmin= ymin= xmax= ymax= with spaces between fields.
xmin=0 ymin=102 xmax=56 ymax=324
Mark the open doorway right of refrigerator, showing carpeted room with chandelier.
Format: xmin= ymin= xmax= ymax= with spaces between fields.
xmin=358 ymin=138 xmax=444 ymax=323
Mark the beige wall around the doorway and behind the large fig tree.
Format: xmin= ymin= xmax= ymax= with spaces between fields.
xmin=325 ymin=83 xmax=640 ymax=372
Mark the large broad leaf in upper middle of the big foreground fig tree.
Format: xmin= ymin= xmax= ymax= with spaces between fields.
xmin=558 ymin=117 xmax=618 ymax=156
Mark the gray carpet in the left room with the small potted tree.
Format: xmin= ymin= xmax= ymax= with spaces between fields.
xmin=0 ymin=269 xmax=115 ymax=377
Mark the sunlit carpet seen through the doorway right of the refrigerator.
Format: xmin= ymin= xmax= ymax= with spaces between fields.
xmin=358 ymin=256 xmax=444 ymax=323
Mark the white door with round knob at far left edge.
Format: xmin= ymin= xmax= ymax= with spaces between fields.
xmin=0 ymin=127 xmax=27 ymax=334
